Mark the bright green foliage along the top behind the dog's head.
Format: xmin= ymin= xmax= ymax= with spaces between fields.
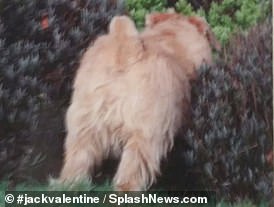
xmin=126 ymin=0 xmax=271 ymax=44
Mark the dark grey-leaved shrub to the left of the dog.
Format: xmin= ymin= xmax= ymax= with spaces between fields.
xmin=0 ymin=0 xmax=123 ymax=183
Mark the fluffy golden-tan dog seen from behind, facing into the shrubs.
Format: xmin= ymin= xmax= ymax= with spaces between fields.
xmin=60 ymin=13 xmax=219 ymax=191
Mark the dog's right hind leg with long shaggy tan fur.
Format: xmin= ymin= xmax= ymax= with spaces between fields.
xmin=113 ymin=134 xmax=160 ymax=191
